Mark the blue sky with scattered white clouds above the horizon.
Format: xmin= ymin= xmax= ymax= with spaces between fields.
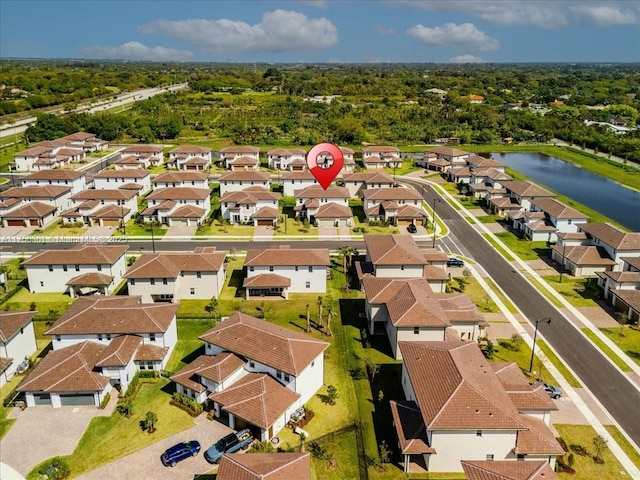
xmin=0 ymin=0 xmax=640 ymax=63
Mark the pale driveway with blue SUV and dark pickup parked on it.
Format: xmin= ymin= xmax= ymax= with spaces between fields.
xmin=77 ymin=413 xmax=235 ymax=480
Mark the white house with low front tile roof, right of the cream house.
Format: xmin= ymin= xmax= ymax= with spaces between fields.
xmin=242 ymin=245 xmax=330 ymax=298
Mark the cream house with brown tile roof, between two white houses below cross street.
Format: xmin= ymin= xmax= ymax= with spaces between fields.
xmin=124 ymin=247 xmax=226 ymax=302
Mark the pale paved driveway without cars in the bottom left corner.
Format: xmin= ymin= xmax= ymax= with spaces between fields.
xmin=0 ymin=395 xmax=118 ymax=476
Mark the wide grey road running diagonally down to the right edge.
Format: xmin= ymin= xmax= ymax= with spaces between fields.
xmin=409 ymin=178 xmax=640 ymax=445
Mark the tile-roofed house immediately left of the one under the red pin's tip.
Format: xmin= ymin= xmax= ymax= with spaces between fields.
xmin=220 ymin=187 xmax=280 ymax=226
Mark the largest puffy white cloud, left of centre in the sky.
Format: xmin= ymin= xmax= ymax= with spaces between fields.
xmin=138 ymin=10 xmax=338 ymax=56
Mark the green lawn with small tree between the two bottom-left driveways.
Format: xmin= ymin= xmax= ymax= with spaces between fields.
xmin=27 ymin=378 xmax=194 ymax=479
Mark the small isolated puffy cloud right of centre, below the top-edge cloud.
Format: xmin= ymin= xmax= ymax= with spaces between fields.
xmin=407 ymin=23 xmax=500 ymax=52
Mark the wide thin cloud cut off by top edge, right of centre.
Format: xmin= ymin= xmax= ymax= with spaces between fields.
xmin=396 ymin=0 xmax=568 ymax=28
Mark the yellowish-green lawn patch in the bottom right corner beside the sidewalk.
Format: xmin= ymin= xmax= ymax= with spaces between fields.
xmin=554 ymin=424 xmax=630 ymax=480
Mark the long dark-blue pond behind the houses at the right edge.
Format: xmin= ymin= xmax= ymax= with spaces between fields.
xmin=492 ymin=153 xmax=640 ymax=232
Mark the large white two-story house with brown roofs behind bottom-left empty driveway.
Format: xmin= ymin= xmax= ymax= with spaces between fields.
xmin=19 ymin=296 xmax=178 ymax=407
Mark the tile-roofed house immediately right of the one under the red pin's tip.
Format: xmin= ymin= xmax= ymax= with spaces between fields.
xmin=363 ymin=187 xmax=426 ymax=226
